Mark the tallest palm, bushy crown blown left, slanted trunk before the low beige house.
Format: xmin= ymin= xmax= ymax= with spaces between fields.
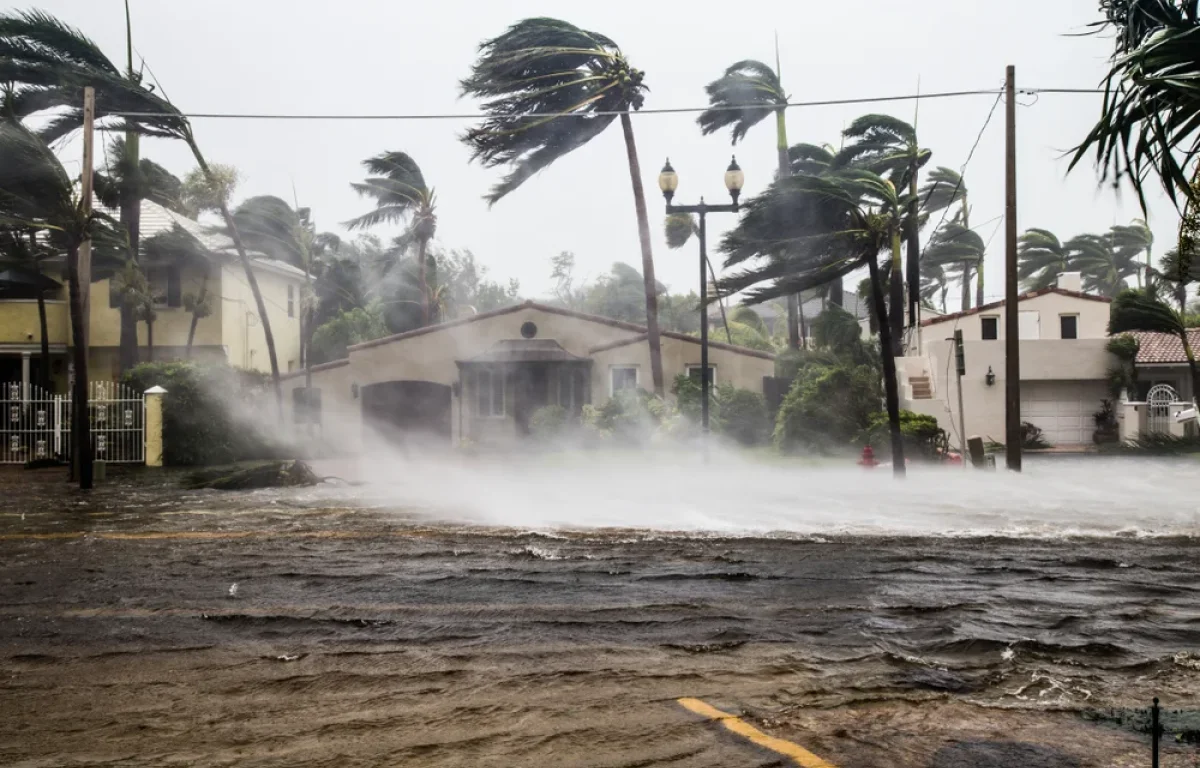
xmin=461 ymin=18 xmax=664 ymax=396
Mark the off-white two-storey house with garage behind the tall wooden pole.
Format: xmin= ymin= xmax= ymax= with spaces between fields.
xmin=896 ymin=272 xmax=1115 ymax=448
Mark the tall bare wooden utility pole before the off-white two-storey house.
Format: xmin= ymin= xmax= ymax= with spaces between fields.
xmin=1004 ymin=65 xmax=1021 ymax=472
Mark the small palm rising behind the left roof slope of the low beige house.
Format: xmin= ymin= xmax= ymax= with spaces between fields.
xmin=346 ymin=152 xmax=438 ymax=325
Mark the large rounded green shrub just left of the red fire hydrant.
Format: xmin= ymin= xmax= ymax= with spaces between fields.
xmin=774 ymin=362 xmax=882 ymax=451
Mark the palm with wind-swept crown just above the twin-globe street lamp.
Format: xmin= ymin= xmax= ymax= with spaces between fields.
xmin=696 ymin=56 xmax=800 ymax=340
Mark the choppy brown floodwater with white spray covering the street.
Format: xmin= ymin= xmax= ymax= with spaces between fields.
xmin=0 ymin=455 xmax=1200 ymax=768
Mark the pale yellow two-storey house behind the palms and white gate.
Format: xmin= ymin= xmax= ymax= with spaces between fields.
xmin=0 ymin=200 xmax=305 ymax=390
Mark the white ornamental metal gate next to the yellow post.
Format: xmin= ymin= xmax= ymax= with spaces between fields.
xmin=0 ymin=382 xmax=145 ymax=464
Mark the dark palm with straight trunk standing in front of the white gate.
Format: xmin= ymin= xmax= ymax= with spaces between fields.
xmin=0 ymin=119 xmax=124 ymax=488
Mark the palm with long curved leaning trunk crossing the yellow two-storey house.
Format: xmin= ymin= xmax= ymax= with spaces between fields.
xmin=0 ymin=11 xmax=283 ymax=412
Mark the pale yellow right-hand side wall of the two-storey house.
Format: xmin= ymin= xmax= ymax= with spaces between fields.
xmin=222 ymin=262 xmax=304 ymax=373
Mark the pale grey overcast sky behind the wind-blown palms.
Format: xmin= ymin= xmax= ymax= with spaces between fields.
xmin=35 ymin=0 xmax=1177 ymax=308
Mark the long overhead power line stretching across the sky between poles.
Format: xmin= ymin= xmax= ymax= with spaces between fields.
xmin=109 ymin=88 xmax=1104 ymax=120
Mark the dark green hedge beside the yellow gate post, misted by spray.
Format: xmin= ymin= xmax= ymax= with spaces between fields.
xmin=124 ymin=362 xmax=280 ymax=467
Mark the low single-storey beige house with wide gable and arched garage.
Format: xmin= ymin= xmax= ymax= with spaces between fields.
xmin=284 ymin=301 xmax=774 ymax=452
